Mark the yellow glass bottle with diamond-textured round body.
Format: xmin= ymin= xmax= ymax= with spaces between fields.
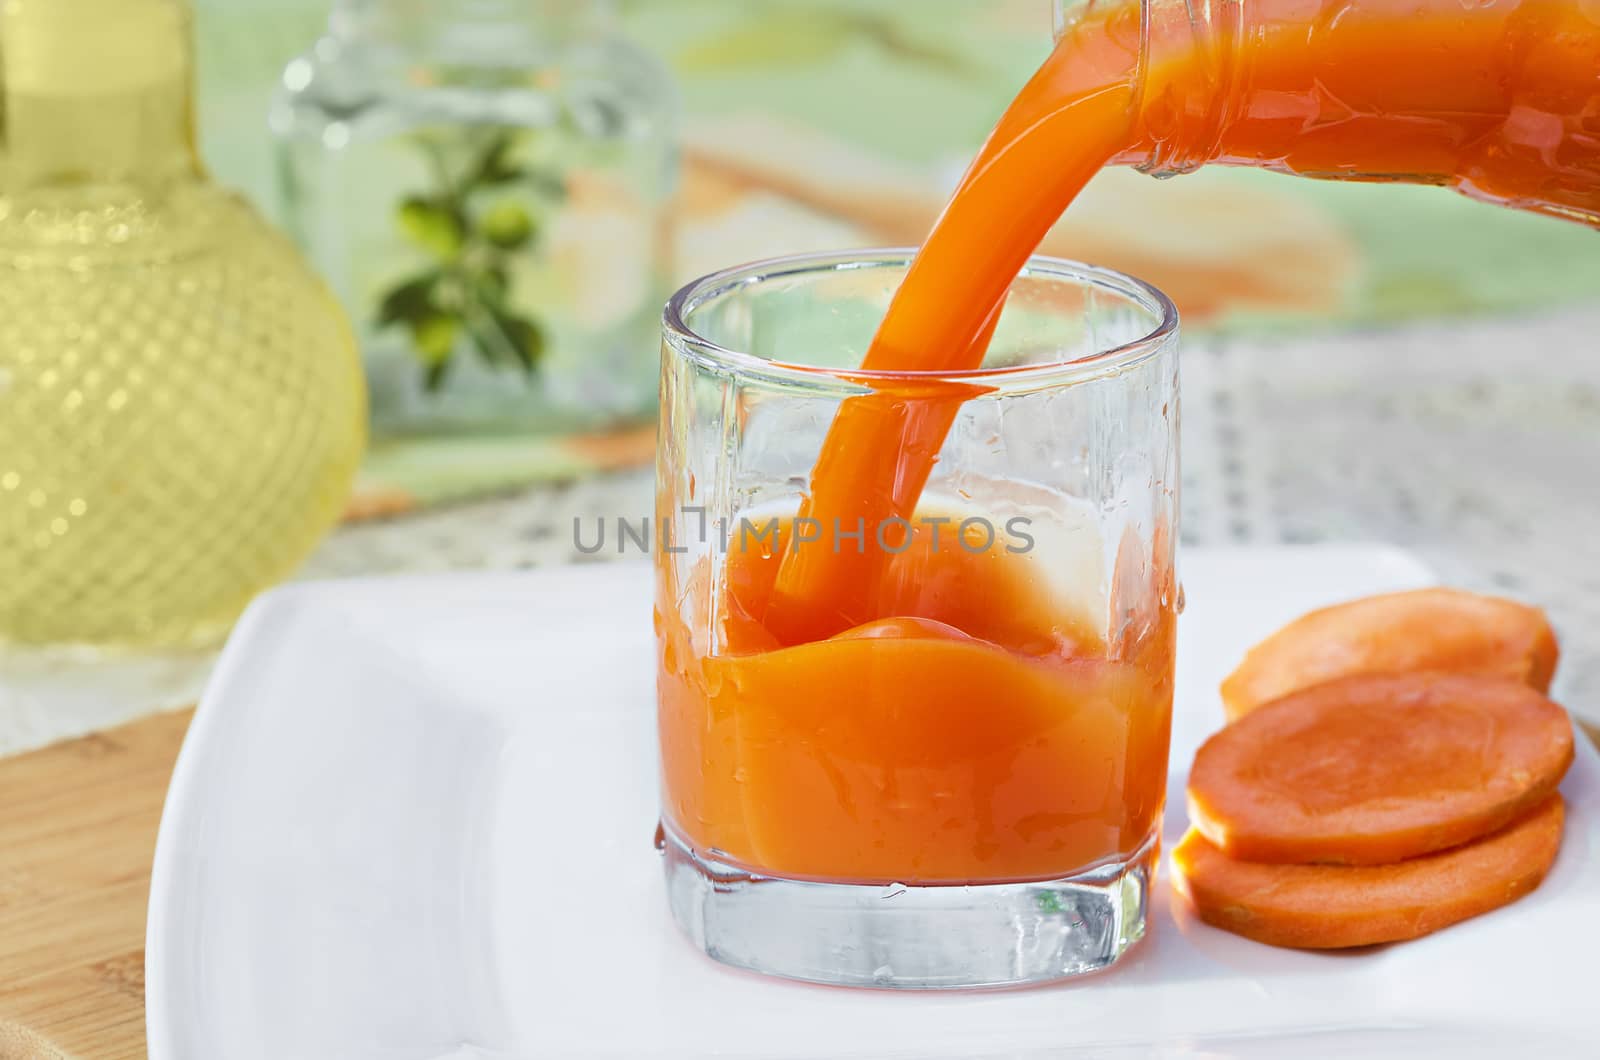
xmin=0 ymin=0 xmax=365 ymax=647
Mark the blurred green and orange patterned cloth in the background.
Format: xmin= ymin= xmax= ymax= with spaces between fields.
xmin=195 ymin=0 xmax=1600 ymax=517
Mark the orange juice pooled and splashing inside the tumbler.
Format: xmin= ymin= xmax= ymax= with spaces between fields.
xmin=658 ymin=520 xmax=1173 ymax=884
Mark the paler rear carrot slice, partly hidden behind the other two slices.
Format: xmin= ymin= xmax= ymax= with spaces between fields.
xmin=1222 ymin=589 xmax=1558 ymax=721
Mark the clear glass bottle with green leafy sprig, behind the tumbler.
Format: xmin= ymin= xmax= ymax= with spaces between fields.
xmin=272 ymin=0 xmax=675 ymax=436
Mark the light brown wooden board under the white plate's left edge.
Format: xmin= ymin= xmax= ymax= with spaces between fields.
xmin=0 ymin=711 xmax=192 ymax=1060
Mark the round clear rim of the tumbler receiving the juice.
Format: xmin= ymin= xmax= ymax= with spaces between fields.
xmin=661 ymin=247 xmax=1179 ymax=392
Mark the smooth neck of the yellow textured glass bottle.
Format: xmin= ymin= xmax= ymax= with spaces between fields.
xmin=0 ymin=0 xmax=202 ymax=195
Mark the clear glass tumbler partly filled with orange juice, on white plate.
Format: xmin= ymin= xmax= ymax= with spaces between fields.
xmin=654 ymin=250 xmax=1179 ymax=988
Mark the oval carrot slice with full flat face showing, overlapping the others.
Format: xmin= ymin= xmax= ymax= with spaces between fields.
xmin=1189 ymin=674 xmax=1573 ymax=865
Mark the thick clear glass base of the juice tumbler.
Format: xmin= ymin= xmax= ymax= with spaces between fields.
xmin=661 ymin=828 xmax=1158 ymax=990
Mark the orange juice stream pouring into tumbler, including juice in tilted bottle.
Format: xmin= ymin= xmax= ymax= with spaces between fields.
xmin=762 ymin=0 xmax=1600 ymax=644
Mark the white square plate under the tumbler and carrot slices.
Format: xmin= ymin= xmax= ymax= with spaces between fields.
xmin=147 ymin=548 xmax=1600 ymax=1060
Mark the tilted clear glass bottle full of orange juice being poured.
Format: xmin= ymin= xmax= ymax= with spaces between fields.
xmin=1058 ymin=0 xmax=1600 ymax=224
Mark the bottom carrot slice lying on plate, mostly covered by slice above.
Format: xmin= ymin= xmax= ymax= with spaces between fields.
xmin=1173 ymin=794 xmax=1565 ymax=950
